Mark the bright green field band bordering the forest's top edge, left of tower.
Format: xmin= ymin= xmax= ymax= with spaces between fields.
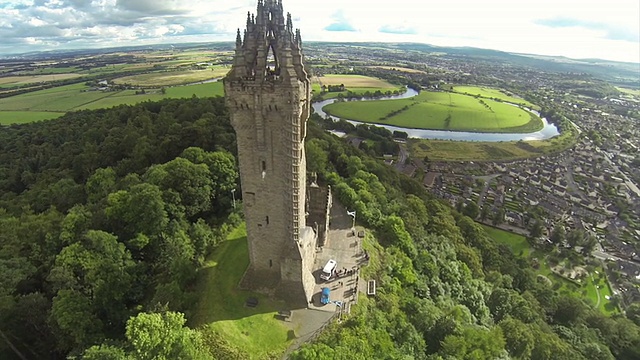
xmin=0 ymin=82 xmax=224 ymax=124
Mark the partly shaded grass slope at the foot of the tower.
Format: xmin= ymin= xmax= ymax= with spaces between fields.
xmin=190 ymin=225 xmax=291 ymax=359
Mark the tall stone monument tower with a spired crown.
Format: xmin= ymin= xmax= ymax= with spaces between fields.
xmin=224 ymin=0 xmax=317 ymax=304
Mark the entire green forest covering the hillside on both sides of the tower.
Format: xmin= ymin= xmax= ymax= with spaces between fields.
xmin=0 ymin=97 xmax=640 ymax=360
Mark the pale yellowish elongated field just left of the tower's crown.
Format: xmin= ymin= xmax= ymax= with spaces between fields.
xmin=114 ymin=67 xmax=229 ymax=86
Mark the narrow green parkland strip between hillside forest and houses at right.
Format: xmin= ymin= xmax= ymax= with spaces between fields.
xmin=482 ymin=225 xmax=618 ymax=314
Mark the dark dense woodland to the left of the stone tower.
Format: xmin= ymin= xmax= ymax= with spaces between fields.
xmin=0 ymin=98 xmax=238 ymax=359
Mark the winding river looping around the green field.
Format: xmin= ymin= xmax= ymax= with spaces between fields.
xmin=312 ymin=89 xmax=560 ymax=141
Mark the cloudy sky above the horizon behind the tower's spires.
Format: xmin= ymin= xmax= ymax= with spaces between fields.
xmin=0 ymin=0 xmax=640 ymax=62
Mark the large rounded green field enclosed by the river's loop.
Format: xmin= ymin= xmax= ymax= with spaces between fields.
xmin=323 ymin=91 xmax=543 ymax=133
